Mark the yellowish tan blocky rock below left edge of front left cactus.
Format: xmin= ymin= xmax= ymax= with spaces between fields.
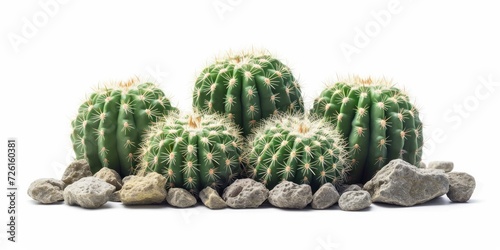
xmin=120 ymin=172 xmax=167 ymax=205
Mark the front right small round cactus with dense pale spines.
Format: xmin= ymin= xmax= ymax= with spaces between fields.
xmin=246 ymin=115 xmax=349 ymax=190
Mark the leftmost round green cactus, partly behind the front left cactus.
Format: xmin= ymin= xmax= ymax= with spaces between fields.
xmin=71 ymin=78 xmax=177 ymax=177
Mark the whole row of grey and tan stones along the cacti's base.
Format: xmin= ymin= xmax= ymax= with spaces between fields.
xmin=28 ymin=160 xmax=475 ymax=211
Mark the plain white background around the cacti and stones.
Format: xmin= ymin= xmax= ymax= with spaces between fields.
xmin=0 ymin=0 xmax=500 ymax=250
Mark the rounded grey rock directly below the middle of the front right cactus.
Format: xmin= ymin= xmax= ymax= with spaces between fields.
xmin=267 ymin=181 xmax=312 ymax=209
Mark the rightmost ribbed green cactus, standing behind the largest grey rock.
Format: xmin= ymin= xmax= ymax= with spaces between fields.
xmin=311 ymin=76 xmax=423 ymax=183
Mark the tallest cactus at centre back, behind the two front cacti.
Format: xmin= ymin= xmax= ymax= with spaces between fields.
xmin=193 ymin=52 xmax=304 ymax=136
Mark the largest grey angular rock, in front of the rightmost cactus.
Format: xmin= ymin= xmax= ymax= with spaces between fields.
xmin=364 ymin=159 xmax=449 ymax=206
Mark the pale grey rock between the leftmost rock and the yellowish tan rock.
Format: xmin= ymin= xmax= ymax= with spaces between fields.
xmin=63 ymin=177 xmax=116 ymax=208
